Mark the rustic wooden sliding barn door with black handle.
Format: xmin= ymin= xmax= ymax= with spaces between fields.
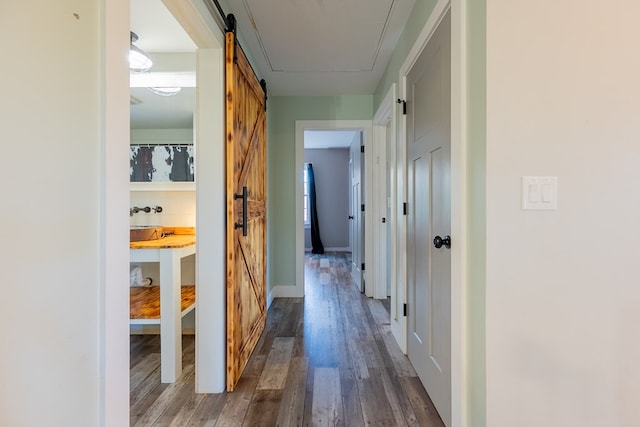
xmin=225 ymin=33 xmax=267 ymax=391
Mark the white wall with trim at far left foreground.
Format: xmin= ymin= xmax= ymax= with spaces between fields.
xmin=0 ymin=0 xmax=129 ymax=427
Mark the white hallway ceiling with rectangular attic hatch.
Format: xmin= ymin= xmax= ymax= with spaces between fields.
xmin=225 ymin=0 xmax=415 ymax=95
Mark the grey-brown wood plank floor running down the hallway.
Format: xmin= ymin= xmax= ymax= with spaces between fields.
xmin=130 ymin=254 xmax=443 ymax=427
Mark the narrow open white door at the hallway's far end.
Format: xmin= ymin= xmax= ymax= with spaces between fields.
xmin=349 ymin=138 xmax=364 ymax=292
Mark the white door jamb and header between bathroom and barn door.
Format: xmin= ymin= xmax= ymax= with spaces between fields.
xmin=162 ymin=0 xmax=226 ymax=393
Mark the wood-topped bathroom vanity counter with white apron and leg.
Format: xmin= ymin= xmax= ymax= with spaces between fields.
xmin=129 ymin=228 xmax=196 ymax=383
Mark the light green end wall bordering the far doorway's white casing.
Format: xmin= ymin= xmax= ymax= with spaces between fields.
xmin=267 ymin=95 xmax=373 ymax=290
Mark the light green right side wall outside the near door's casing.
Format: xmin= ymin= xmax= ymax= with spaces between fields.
xmin=374 ymin=0 xmax=486 ymax=427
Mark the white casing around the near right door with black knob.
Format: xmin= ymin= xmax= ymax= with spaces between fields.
xmin=397 ymin=0 xmax=469 ymax=427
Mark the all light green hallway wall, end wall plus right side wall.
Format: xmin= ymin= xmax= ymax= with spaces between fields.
xmin=267 ymin=0 xmax=486 ymax=427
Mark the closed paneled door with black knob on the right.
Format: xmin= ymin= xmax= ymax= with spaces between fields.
xmin=407 ymin=12 xmax=451 ymax=425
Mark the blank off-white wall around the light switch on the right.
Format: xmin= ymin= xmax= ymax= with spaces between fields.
xmin=486 ymin=0 xmax=640 ymax=427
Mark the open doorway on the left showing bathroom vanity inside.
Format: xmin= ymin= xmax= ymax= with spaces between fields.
xmin=129 ymin=0 xmax=197 ymax=392
